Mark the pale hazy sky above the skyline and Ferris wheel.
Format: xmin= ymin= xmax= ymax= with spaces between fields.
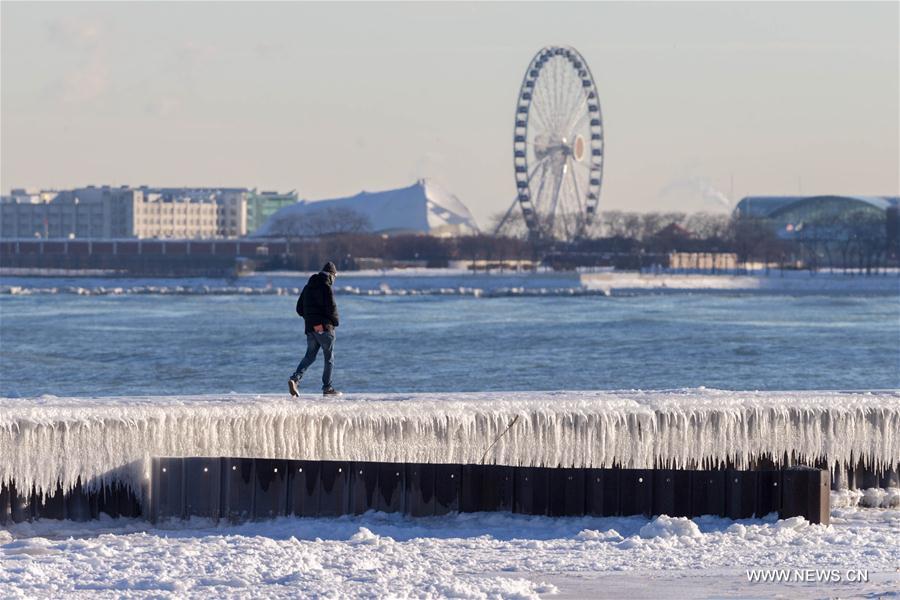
xmin=0 ymin=2 xmax=900 ymax=224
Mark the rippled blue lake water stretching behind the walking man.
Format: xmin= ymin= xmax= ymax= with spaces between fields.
xmin=0 ymin=278 xmax=900 ymax=397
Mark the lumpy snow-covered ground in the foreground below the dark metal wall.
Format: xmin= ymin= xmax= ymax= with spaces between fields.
xmin=0 ymin=506 xmax=900 ymax=599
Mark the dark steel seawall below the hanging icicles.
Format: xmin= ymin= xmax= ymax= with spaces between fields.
xmin=0 ymin=457 xmax=852 ymax=524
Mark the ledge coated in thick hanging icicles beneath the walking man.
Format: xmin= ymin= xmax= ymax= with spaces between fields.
xmin=0 ymin=389 xmax=900 ymax=490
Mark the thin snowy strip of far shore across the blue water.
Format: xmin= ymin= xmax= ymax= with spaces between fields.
xmin=0 ymin=268 xmax=900 ymax=297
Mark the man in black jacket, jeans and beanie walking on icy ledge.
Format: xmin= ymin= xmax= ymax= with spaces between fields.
xmin=288 ymin=262 xmax=341 ymax=396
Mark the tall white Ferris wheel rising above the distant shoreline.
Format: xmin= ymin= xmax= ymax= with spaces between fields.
xmin=498 ymin=47 xmax=603 ymax=240
